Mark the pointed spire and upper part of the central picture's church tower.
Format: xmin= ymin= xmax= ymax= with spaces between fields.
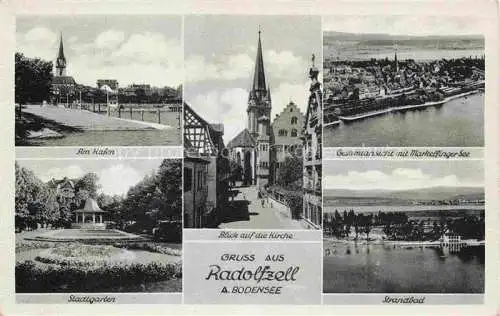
xmin=247 ymin=28 xmax=271 ymax=139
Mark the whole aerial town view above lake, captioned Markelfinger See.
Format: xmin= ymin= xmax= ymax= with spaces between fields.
xmin=323 ymin=16 xmax=485 ymax=147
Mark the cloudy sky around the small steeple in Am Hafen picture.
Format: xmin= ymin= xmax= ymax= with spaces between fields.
xmin=16 ymin=15 xmax=183 ymax=87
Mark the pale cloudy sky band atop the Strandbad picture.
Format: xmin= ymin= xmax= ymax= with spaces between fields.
xmin=323 ymin=160 xmax=484 ymax=190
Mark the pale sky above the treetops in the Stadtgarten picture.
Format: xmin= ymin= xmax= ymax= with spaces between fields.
xmin=17 ymin=159 xmax=172 ymax=195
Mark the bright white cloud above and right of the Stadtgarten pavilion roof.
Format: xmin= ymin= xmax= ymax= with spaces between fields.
xmin=98 ymin=164 xmax=144 ymax=195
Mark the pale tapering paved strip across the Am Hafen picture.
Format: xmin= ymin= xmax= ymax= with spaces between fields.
xmin=23 ymin=105 xmax=171 ymax=131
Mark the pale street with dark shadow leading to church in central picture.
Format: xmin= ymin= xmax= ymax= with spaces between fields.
xmin=219 ymin=187 xmax=304 ymax=229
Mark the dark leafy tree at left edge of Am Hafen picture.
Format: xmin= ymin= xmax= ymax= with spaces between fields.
xmin=15 ymin=53 xmax=53 ymax=104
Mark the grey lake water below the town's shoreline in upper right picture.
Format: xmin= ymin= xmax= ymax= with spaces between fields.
xmin=323 ymin=93 xmax=484 ymax=147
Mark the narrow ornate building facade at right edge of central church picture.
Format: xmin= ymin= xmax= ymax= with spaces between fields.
xmin=302 ymin=55 xmax=323 ymax=228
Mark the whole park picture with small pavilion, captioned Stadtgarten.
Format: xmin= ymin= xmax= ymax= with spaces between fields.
xmin=15 ymin=159 xmax=182 ymax=293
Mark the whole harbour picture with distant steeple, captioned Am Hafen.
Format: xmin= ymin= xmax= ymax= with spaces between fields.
xmin=15 ymin=16 xmax=183 ymax=146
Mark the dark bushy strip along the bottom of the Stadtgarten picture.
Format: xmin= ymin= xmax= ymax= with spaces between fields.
xmin=16 ymin=260 xmax=182 ymax=293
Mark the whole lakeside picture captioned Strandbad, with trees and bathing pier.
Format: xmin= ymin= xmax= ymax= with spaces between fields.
xmin=323 ymin=160 xmax=485 ymax=293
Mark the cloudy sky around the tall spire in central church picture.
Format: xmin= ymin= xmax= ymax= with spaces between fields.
xmin=184 ymin=15 xmax=322 ymax=144
